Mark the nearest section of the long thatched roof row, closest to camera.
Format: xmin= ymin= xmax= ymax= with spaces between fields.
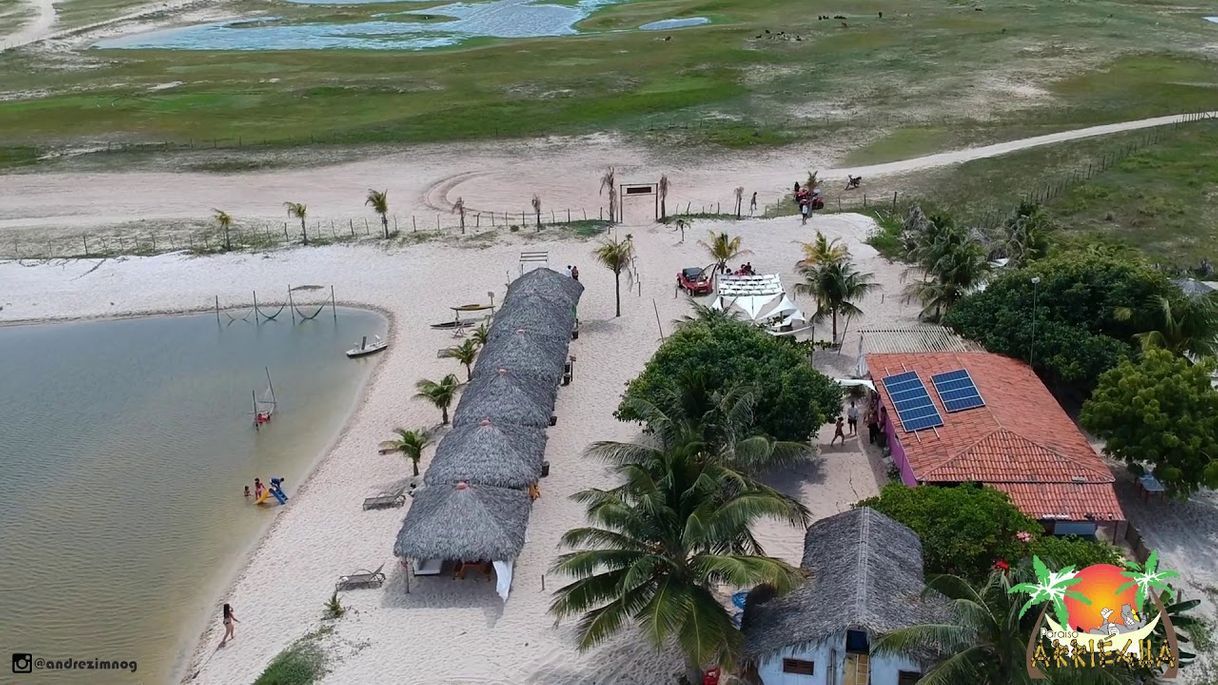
xmin=393 ymin=483 xmax=531 ymax=561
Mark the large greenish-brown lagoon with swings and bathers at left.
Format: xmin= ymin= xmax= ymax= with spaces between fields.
xmin=0 ymin=308 xmax=387 ymax=683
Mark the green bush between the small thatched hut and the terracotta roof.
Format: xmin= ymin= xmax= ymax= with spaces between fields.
xmin=855 ymin=483 xmax=1041 ymax=580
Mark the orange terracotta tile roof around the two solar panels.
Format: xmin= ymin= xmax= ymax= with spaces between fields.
xmin=867 ymin=352 xmax=1124 ymax=520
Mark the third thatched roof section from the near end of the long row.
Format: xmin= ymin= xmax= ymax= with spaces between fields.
xmin=453 ymin=368 xmax=558 ymax=428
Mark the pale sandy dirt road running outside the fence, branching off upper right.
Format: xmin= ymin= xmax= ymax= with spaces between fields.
xmin=0 ymin=112 xmax=1218 ymax=239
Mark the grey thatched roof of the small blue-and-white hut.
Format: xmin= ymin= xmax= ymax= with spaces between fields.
xmin=742 ymin=507 xmax=946 ymax=658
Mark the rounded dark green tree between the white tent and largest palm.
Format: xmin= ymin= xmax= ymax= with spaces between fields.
xmin=615 ymin=319 xmax=842 ymax=441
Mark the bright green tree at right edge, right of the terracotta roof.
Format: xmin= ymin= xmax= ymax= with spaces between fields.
xmin=1082 ymin=350 xmax=1218 ymax=494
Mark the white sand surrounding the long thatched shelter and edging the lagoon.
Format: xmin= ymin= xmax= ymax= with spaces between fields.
xmin=0 ymin=215 xmax=912 ymax=685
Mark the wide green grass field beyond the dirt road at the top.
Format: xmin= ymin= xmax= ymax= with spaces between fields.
xmin=0 ymin=0 xmax=1218 ymax=165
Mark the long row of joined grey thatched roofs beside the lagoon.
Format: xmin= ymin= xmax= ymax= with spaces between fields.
xmin=393 ymin=269 xmax=583 ymax=565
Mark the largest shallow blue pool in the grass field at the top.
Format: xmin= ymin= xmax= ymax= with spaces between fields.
xmin=95 ymin=0 xmax=621 ymax=50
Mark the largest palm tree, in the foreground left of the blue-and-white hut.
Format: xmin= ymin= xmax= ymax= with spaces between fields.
xmin=549 ymin=450 xmax=803 ymax=683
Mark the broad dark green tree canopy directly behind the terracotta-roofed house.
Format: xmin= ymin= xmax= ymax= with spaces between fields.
xmin=944 ymin=250 xmax=1178 ymax=394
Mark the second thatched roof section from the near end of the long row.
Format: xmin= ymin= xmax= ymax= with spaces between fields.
xmin=423 ymin=419 xmax=546 ymax=489
